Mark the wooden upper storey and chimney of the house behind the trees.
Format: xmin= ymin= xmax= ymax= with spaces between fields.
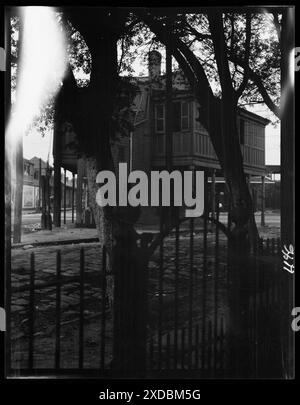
xmin=127 ymin=51 xmax=269 ymax=172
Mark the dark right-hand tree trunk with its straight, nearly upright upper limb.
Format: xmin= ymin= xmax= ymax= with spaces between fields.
xmin=208 ymin=10 xmax=257 ymax=248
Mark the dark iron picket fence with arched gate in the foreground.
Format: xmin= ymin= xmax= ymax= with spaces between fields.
xmin=7 ymin=211 xmax=283 ymax=378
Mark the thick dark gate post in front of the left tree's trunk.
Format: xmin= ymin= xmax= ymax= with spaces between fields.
xmin=112 ymin=207 xmax=147 ymax=377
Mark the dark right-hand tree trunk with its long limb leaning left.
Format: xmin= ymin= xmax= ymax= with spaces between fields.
xmin=135 ymin=10 xmax=258 ymax=246
